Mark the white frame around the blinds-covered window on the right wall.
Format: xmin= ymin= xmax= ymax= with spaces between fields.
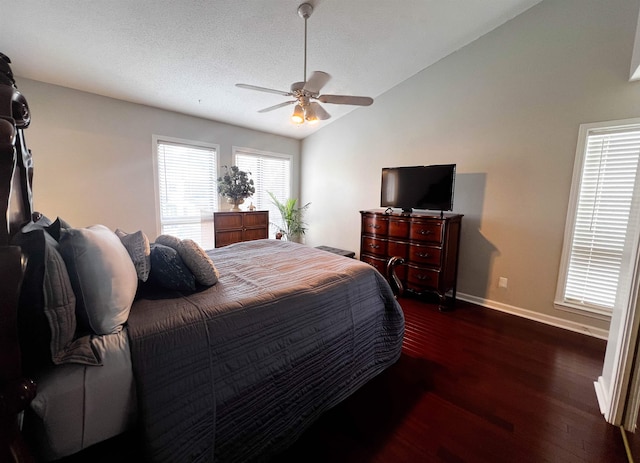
xmin=554 ymin=118 xmax=640 ymax=321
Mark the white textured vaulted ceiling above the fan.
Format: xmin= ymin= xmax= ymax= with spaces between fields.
xmin=0 ymin=0 xmax=541 ymax=139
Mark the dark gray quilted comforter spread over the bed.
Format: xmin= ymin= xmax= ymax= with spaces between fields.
xmin=129 ymin=240 xmax=404 ymax=463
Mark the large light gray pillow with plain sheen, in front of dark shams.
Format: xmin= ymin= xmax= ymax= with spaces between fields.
xmin=60 ymin=225 xmax=138 ymax=334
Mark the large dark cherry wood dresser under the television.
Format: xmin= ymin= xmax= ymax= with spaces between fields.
xmin=360 ymin=210 xmax=462 ymax=310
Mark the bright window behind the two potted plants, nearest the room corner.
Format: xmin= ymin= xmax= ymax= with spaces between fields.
xmin=234 ymin=148 xmax=292 ymax=238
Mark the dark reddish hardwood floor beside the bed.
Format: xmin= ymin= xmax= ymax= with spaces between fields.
xmin=57 ymin=299 xmax=628 ymax=463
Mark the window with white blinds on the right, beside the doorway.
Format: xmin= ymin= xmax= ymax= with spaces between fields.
xmin=555 ymin=120 xmax=640 ymax=317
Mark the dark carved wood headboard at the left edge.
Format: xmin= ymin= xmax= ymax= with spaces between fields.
xmin=0 ymin=53 xmax=36 ymax=462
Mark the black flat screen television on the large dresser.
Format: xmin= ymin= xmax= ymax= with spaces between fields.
xmin=380 ymin=164 xmax=456 ymax=212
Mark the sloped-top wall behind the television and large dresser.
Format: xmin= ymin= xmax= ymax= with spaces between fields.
xmin=301 ymin=0 xmax=640 ymax=335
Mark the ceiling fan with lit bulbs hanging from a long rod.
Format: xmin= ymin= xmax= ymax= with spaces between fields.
xmin=236 ymin=3 xmax=373 ymax=124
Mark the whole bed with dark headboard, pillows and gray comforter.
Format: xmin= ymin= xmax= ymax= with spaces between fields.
xmin=0 ymin=52 xmax=404 ymax=462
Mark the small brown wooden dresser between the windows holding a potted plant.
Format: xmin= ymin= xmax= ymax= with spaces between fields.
xmin=213 ymin=211 xmax=269 ymax=248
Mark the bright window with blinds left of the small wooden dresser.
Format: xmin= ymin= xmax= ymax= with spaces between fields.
xmin=154 ymin=137 xmax=218 ymax=249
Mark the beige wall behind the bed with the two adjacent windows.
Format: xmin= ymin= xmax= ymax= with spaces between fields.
xmin=17 ymin=78 xmax=300 ymax=239
